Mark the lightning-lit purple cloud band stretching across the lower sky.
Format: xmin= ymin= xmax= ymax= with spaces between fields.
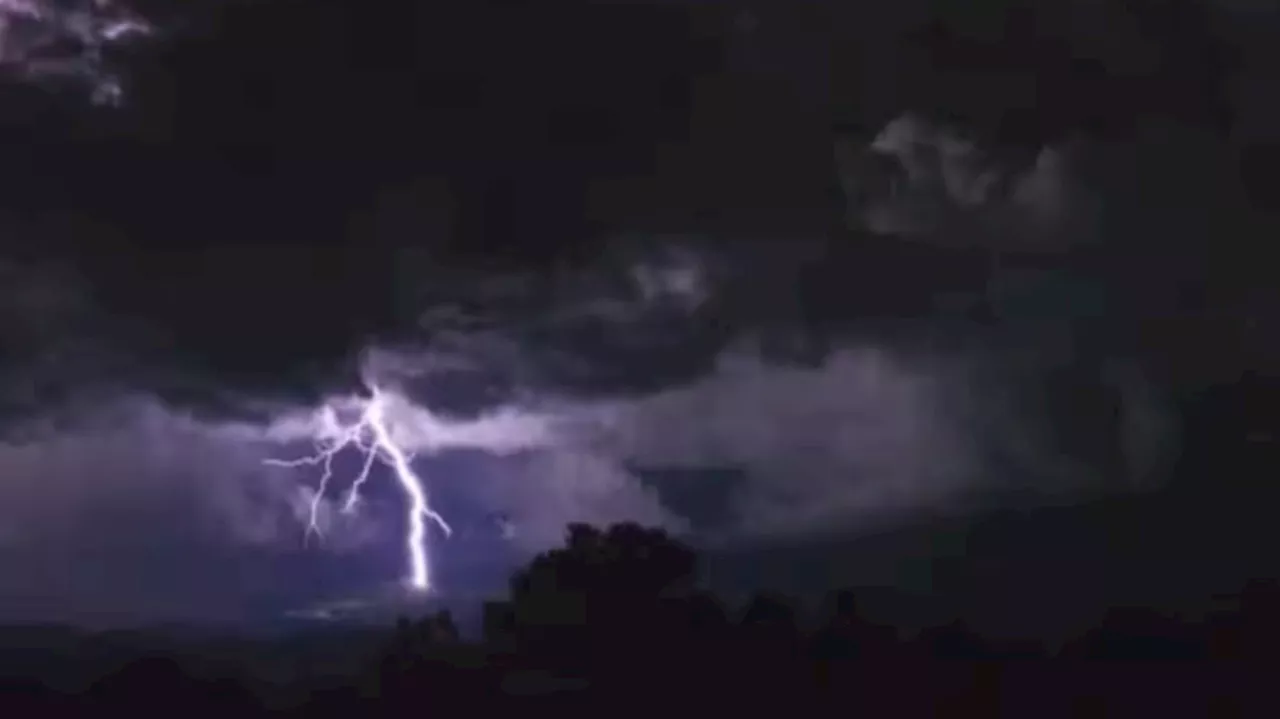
xmin=0 ymin=211 xmax=1167 ymax=620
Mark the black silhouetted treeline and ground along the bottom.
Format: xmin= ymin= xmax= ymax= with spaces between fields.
xmin=0 ymin=516 xmax=1280 ymax=716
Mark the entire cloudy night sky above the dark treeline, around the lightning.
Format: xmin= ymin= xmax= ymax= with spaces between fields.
xmin=0 ymin=0 xmax=1280 ymax=624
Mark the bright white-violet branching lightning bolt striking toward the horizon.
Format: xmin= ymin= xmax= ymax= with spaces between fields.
xmin=265 ymin=386 xmax=453 ymax=591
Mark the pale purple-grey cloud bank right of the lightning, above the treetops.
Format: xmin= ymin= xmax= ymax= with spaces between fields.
xmin=586 ymin=345 xmax=979 ymax=537
